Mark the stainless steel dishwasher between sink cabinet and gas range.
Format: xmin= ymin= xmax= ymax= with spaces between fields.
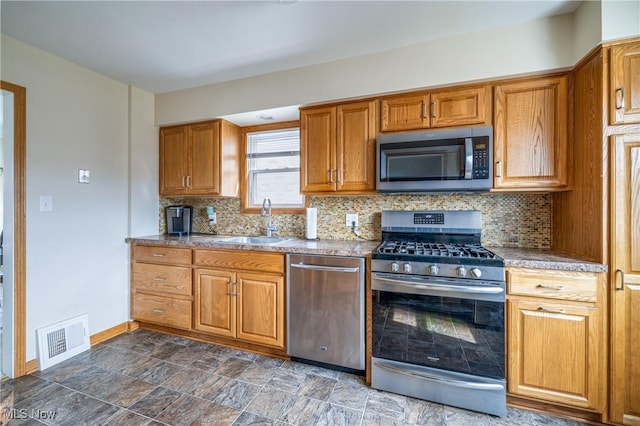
xmin=287 ymin=254 xmax=365 ymax=370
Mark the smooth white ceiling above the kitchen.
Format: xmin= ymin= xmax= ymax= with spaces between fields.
xmin=0 ymin=0 xmax=580 ymax=123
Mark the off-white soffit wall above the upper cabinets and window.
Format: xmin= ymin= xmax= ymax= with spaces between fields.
xmin=155 ymin=15 xmax=575 ymax=125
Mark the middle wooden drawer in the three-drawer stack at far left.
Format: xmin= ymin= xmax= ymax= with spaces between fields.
xmin=131 ymin=263 xmax=192 ymax=296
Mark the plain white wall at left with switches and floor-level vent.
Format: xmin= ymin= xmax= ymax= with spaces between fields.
xmin=2 ymin=35 xmax=157 ymax=360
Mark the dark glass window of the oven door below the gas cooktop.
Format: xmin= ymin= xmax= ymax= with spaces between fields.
xmin=373 ymin=291 xmax=505 ymax=379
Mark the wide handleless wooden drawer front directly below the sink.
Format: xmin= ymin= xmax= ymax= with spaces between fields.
xmin=194 ymin=250 xmax=284 ymax=274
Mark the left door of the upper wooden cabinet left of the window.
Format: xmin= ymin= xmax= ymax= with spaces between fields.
xmin=160 ymin=126 xmax=189 ymax=195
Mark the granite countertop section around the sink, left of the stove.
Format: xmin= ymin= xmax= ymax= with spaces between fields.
xmin=126 ymin=234 xmax=380 ymax=256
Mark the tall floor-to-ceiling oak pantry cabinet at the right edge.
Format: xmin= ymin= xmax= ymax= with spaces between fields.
xmin=552 ymin=39 xmax=640 ymax=425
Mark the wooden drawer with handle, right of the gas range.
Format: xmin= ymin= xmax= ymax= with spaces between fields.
xmin=507 ymin=269 xmax=598 ymax=302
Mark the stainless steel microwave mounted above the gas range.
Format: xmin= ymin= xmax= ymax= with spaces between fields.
xmin=376 ymin=126 xmax=493 ymax=192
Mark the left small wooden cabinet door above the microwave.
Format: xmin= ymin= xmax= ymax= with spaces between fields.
xmin=380 ymin=93 xmax=429 ymax=132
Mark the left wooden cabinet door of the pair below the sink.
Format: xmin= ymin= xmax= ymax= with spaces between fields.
xmin=194 ymin=269 xmax=237 ymax=337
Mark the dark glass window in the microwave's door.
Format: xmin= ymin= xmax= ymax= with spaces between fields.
xmin=381 ymin=143 xmax=465 ymax=181
